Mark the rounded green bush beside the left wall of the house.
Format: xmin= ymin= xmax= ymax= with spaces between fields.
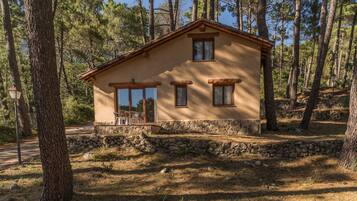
xmin=63 ymin=97 xmax=94 ymax=125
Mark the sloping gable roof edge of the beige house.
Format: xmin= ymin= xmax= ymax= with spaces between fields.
xmin=80 ymin=19 xmax=273 ymax=81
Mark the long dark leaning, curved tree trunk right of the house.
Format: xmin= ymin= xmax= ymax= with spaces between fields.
xmin=300 ymin=0 xmax=337 ymax=129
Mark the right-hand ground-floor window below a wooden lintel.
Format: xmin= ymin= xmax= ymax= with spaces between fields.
xmin=213 ymin=85 xmax=234 ymax=106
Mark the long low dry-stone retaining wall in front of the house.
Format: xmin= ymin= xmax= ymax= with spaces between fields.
xmin=67 ymin=134 xmax=343 ymax=158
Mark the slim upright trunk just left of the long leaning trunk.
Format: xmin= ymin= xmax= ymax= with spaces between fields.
xmin=290 ymin=0 xmax=301 ymax=109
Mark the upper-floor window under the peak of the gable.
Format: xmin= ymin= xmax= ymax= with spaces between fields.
xmin=192 ymin=38 xmax=214 ymax=61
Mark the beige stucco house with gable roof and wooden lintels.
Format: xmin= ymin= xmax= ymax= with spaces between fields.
xmin=81 ymin=20 xmax=272 ymax=134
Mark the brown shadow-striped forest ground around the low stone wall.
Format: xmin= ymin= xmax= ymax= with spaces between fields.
xmin=0 ymin=121 xmax=357 ymax=201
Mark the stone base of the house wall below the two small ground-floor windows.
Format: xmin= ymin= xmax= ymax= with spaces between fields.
xmin=159 ymin=120 xmax=260 ymax=135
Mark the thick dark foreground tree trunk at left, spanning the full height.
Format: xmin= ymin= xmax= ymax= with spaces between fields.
xmin=25 ymin=0 xmax=73 ymax=201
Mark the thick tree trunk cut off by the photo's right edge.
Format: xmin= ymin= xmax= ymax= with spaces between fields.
xmin=340 ymin=36 xmax=357 ymax=169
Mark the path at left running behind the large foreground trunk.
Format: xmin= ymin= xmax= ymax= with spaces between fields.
xmin=0 ymin=126 xmax=93 ymax=170
